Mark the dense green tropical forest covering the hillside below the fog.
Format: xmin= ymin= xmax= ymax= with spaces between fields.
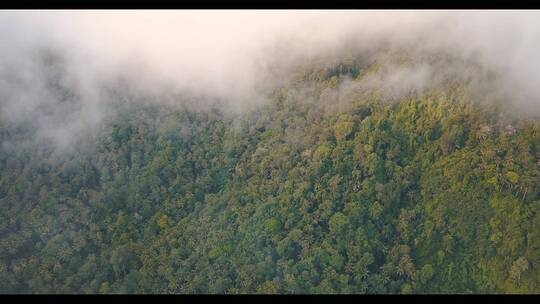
xmin=0 ymin=50 xmax=540 ymax=294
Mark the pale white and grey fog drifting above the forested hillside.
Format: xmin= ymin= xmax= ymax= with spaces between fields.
xmin=0 ymin=10 xmax=540 ymax=153
